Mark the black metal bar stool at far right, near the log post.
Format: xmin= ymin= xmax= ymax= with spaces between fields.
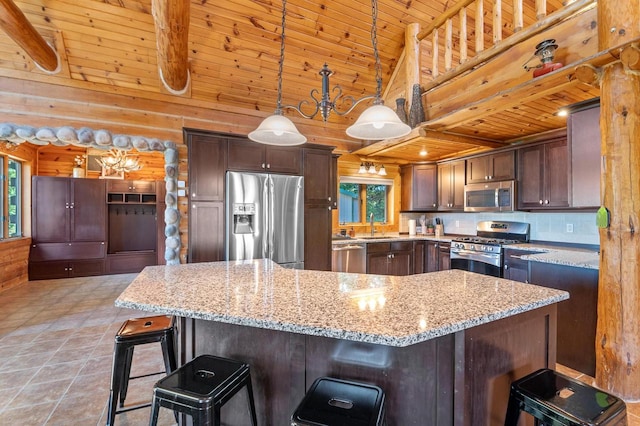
xmin=504 ymin=368 xmax=627 ymax=426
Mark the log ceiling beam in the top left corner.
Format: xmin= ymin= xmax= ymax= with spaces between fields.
xmin=0 ymin=0 xmax=60 ymax=73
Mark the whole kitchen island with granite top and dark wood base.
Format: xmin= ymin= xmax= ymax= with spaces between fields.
xmin=116 ymin=259 xmax=568 ymax=426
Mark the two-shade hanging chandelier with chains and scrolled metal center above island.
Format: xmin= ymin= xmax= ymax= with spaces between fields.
xmin=249 ymin=0 xmax=411 ymax=145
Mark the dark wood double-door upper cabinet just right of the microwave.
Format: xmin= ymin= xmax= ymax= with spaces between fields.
xmin=518 ymin=139 xmax=570 ymax=210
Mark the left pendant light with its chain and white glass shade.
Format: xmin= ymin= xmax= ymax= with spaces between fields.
xmin=249 ymin=0 xmax=307 ymax=146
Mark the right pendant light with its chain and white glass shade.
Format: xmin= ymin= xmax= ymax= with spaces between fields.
xmin=347 ymin=0 xmax=411 ymax=140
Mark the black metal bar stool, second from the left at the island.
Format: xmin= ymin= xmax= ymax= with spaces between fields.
xmin=149 ymin=355 xmax=258 ymax=426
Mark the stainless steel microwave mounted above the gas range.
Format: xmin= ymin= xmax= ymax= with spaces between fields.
xmin=464 ymin=180 xmax=516 ymax=212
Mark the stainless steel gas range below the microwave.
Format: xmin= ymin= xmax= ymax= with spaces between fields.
xmin=450 ymin=221 xmax=530 ymax=277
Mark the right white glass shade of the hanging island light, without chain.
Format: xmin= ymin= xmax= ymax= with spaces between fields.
xmin=347 ymin=104 xmax=411 ymax=140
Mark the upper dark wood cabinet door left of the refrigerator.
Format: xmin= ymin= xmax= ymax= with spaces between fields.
xmin=187 ymin=133 xmax=228 ymax=201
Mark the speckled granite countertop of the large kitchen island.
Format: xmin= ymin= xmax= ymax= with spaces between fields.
xmin=115 ymin=259 xmax=569 ymax=346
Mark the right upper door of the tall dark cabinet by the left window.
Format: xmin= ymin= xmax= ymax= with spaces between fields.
xmin=69 ymin=179 xmax=107 ymax=241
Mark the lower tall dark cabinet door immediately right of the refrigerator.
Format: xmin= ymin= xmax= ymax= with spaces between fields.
xmin=304 ymin=205 xmax=331 ymax=271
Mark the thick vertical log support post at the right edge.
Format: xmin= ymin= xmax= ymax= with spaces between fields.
xmin=596 ymin=0 xmax=640 ymax=401
